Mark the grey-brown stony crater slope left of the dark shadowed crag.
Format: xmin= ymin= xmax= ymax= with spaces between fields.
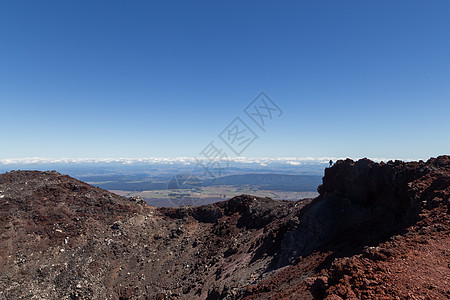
xmin=0 ymin=171 xmax=308 ymax=299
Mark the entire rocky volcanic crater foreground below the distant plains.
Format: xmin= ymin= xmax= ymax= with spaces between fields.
xmin=0 ymin=156 xmax=450 ymax=299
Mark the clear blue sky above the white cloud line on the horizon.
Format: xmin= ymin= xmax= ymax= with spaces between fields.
xmin=0 ymin=0 xmax=450 ymax=159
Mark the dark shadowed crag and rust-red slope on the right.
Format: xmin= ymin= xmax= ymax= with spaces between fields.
xmin=245 ymin=156 xmax=450 ymax=299
